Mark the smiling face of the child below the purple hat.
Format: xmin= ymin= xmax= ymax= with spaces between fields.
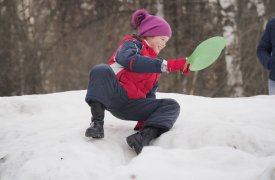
xmin=146 ymin=36 xmax=169 ymax=54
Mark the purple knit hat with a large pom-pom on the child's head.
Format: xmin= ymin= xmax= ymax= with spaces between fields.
xmin=131 ymin=9 xmax=172 ymax=37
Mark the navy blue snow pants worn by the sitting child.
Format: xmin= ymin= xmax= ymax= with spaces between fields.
xmin=85 ymin=64 xmax=180 ymax=131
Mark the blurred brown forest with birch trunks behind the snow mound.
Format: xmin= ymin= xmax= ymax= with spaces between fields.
xmin=0 ymin=0 xmax=275 ymax=97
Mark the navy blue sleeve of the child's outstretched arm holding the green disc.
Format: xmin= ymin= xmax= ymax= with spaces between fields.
xmin=115 ymin=40 xmax=163 ymax=73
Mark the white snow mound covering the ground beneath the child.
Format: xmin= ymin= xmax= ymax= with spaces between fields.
xmin=0 ymin=90 xmax=275 ymax=180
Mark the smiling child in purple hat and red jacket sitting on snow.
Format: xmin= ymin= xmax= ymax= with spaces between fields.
xmin=85 ymin=9 xmax=190 ymax=154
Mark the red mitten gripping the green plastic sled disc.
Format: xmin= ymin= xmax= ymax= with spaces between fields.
xmin=167 ymin=58 xmax=190 ymax=72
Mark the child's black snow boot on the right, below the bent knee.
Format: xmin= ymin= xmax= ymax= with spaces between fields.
xmin=126 ymin=127 xmax=162 ymax=154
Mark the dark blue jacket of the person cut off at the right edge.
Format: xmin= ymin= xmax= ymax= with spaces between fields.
xmin=257 ymin=19 xmax=275 ymax=70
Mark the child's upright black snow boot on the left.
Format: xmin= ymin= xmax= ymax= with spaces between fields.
xmin=85 ymin=102 xmax=105 ymax=138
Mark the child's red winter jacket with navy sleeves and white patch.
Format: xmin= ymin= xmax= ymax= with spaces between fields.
xmin=109 ymin=36 xmax=162 ymax=99
